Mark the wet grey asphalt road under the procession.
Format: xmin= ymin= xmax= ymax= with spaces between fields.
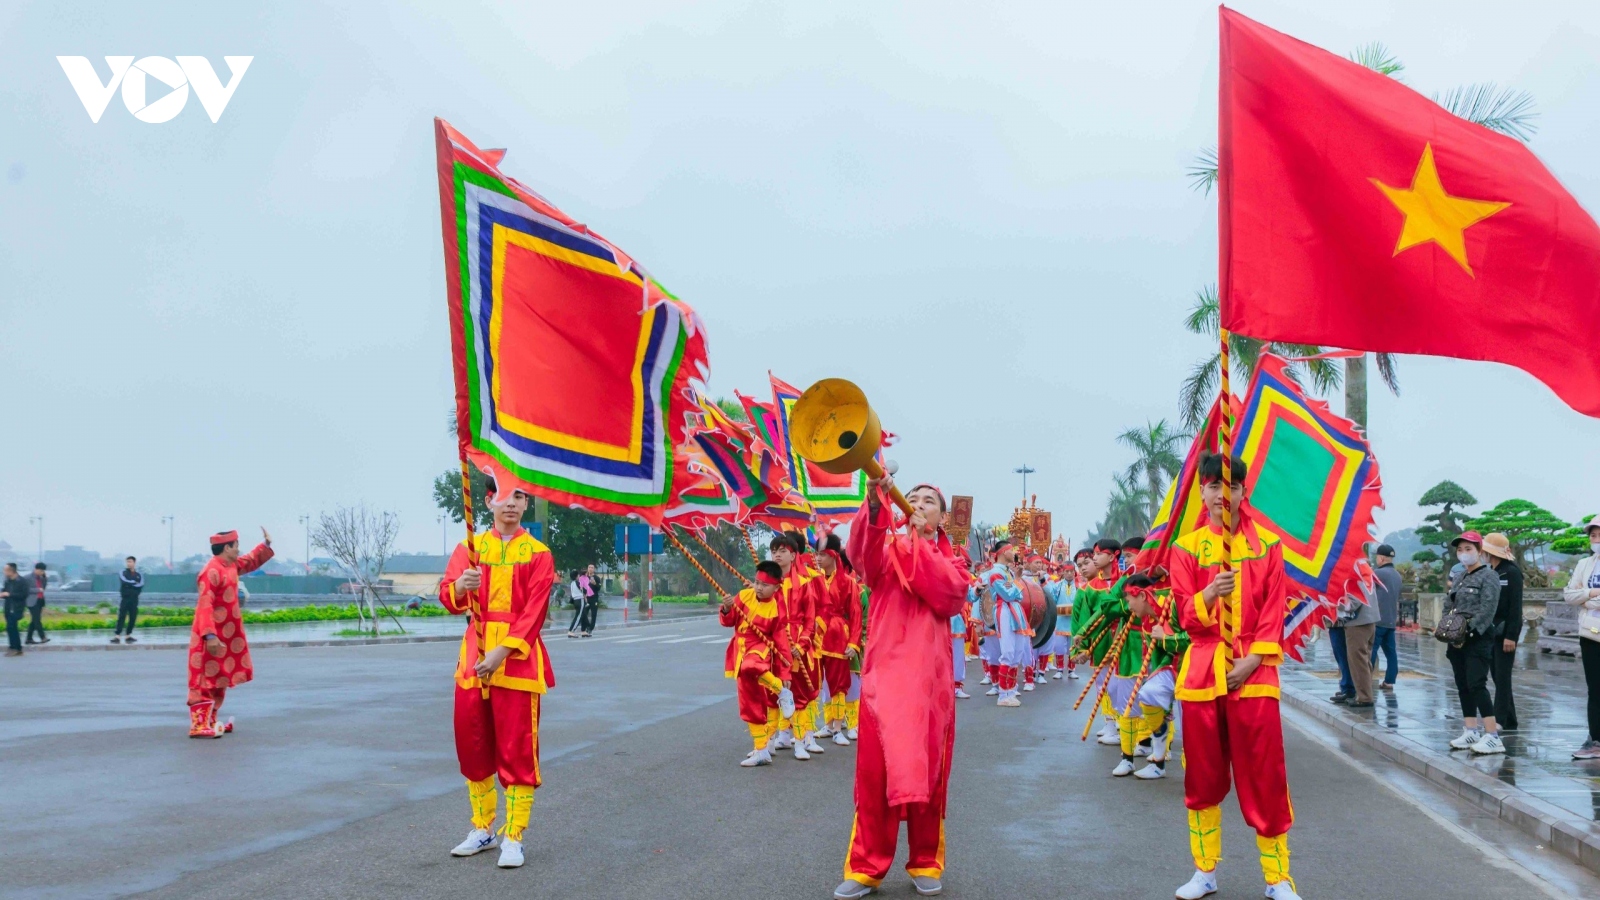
xmin=0 ymin=621 xmax=1600 ymax=900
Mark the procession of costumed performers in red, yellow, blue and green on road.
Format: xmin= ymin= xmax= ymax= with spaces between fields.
xmin=175 ymin=456 xmax=1299 ymax=900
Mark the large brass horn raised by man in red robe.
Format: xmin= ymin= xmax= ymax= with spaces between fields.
xmin=789 ymin=378 xmax=910 ymax=516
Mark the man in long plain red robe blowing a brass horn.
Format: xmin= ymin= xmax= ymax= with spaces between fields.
xmin=834 ymin=477 xmax=968 ymax=900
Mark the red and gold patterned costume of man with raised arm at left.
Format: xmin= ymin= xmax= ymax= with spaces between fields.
xmin=189 ymin=532 xmax=272 ymax=738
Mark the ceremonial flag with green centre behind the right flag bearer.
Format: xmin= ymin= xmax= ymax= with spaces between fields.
xmin=1139 ymin=354 xmax=1382 ymax=660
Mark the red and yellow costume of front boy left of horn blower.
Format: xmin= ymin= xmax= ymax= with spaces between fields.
xmin=718 ymin=588 xmax=792 ymax=749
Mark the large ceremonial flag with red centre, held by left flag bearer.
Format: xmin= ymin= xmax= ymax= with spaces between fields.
xmin=434 ymin=119 xmax=707 ymax=525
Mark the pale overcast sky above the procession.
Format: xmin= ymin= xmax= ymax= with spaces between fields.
xmin=0 ymin=0 xmax=1600 ymax=557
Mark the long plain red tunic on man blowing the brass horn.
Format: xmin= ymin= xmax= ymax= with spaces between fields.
xmin=850 ymin=504 xmax=966 ymax=815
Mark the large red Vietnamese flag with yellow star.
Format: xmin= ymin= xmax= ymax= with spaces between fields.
xmin=1218 ymin=8 xmax=1600 ymax=416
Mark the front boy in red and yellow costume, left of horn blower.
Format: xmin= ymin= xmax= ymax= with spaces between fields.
xmin=717 ymin=562 xmax=795 ymax=769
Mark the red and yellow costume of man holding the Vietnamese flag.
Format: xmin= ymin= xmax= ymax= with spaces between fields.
xmin=1171 ymin=508 xmax=1294 ymax=884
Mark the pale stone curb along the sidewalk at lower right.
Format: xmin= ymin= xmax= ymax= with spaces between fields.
xmin=1280 ymin=685 xmax=1600 ymax=874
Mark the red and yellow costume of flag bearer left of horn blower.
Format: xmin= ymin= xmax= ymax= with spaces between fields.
xmin=438 ymin=528 xmax=555 ymax=841
